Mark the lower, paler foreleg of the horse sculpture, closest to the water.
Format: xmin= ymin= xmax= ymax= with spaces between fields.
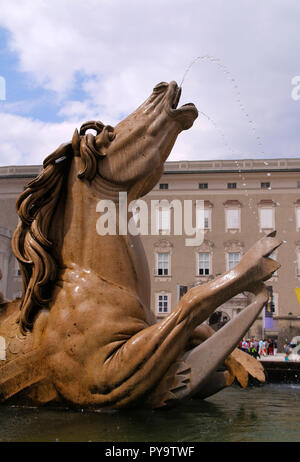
xmin=148 ymin=283 xmax=268 ymax=407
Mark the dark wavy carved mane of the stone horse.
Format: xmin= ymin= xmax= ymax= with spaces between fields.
xmin=12 ymin=121 xmax=108 ymax=334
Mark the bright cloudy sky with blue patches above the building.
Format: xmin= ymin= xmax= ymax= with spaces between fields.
xmin=0 ymin=0 xmax=300 ymax=166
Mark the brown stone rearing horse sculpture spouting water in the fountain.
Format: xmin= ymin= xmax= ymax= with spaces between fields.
xmin=0 ymin=82 xmax=281 ymax=409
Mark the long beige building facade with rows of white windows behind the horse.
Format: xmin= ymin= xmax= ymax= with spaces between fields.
xmin=0 ymin=158 xmax=300 ymax=349
